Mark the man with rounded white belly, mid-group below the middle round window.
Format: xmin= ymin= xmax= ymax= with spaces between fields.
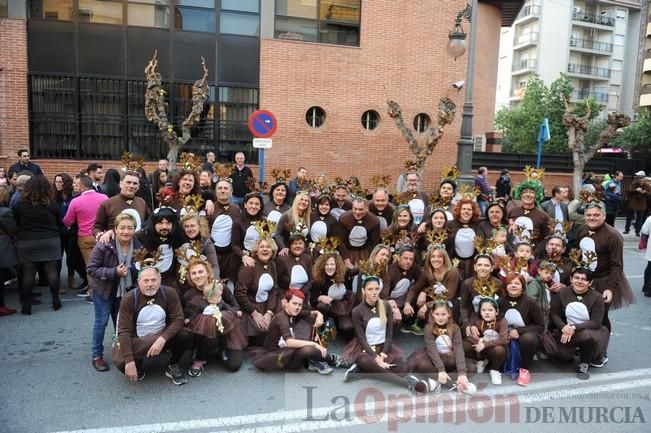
xmin=335 ymin=197 xmax=380 ymax=269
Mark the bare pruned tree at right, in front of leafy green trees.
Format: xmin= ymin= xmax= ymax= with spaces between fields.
xmin=562 ymin=101 xmax=631 ymax=193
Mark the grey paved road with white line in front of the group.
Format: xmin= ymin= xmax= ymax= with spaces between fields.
xmin=0 ymin=223 xmax=651 ymax=433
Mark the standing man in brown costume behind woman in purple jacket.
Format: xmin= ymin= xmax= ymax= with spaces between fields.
xmin=93 ymin=171 xmax=149 ymax=244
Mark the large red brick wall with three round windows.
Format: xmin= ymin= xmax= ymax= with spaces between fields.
xmin=260 ymin=0 xmax=499 ymax=192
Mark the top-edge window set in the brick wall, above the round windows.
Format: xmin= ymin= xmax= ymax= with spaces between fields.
xmin=274 ymin=0 xmax=361 ymax=46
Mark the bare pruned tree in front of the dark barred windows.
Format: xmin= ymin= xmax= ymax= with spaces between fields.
xmin=145 ymin=50 xmax=209 ymax=170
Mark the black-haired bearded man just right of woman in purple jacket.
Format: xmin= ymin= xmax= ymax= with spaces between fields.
xmin=136 ymin=206 xmax=182 ymax=290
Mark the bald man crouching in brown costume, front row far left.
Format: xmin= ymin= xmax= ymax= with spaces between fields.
xmin=112 ymin=267 xmax=192 ymax=385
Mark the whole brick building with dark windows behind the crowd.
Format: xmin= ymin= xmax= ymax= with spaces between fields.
xmin=0 ymin=0 xmax=522 ymax=187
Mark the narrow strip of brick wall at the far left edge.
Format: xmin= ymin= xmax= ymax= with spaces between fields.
xmin=0 ymin=18 xmax=29 ymax=159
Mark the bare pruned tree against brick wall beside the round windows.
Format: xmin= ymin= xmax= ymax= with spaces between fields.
xmin=387 ymin=97 xmax=457 ymax=175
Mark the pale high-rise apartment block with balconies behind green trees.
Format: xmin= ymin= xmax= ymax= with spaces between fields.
xmin=497 ymin=0 xmax=646 ymax=115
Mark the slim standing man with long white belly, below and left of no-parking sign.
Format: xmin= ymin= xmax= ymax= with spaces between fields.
xmin=210 ymin=177 xmax=242 ymax=283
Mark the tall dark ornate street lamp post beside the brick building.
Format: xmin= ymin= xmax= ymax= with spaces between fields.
xmin=447 ymin=0 xmax=478 ymax=185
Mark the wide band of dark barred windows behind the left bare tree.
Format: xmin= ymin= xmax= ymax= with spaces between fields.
xmin=29 ymin=75 xmax=259 ymax=163
